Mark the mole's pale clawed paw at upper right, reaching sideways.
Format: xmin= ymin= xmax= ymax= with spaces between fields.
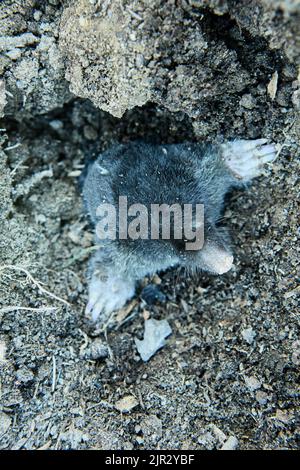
xmin=222 ymin=139 xmax=276 ymax=182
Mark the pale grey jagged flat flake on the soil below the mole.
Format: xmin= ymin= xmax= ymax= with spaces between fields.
xmin=135 ymin=318 xmax=172 ymax=362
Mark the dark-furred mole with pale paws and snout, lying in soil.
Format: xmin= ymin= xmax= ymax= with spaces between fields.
xmin=83 ymin=139 xmax=276 ymax=321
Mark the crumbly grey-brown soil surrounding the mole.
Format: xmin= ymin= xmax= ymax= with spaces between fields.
xmin=0 ymin=0 xmax=300 ymax=449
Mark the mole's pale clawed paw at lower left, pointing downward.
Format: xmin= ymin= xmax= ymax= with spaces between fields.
xmin=85 ymin=274 xmax=135 ymax=322
